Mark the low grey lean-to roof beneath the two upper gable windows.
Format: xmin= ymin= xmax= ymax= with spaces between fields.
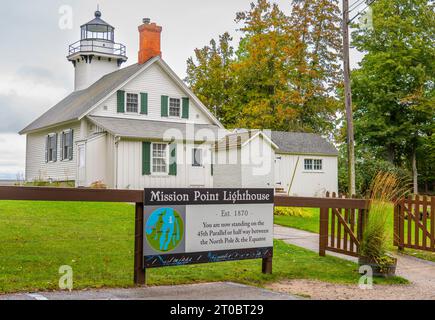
xmin=87 ymin=116 xmax=222 ymax=140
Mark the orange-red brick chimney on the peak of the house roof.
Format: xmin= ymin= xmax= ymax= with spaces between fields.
xmin=139 ymin=18 xmax=162 ymax=64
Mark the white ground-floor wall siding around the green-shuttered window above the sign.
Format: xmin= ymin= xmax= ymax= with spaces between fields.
xmin=116 ymin=140 xmax=213 ymax=190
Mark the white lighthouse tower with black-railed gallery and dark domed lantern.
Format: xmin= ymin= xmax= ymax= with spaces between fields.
xmin=67 ymin=10 xmax=127 ymax=91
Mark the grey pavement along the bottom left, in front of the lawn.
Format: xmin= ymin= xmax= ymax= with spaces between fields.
xmin=0 ymin=282 xmax=300 ymax=301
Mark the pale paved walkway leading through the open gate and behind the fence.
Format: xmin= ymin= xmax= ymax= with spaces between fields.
xmin=268 ymin=226 xmax=435 ymax=300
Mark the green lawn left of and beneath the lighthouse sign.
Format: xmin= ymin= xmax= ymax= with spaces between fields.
xmin=0 ymin=201 xmax=406 ymax=293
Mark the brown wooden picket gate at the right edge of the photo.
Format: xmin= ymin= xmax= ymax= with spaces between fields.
xmin=394 ymin=195 xmax=435 ymax=252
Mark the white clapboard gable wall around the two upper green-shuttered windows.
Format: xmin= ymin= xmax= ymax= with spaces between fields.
xmin=92 ymin=64 xmax=211 ymax=124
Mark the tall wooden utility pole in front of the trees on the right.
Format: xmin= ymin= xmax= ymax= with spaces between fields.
xmin=342 ymin=0 xmax=356 ymax=196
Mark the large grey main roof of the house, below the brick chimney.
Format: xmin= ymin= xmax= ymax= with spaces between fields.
xmin=19 ymin=57 xmax=223 ymax=134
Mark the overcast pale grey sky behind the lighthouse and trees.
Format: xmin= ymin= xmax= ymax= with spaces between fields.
xmin=0 ymin=0 xmax=360 ymax=179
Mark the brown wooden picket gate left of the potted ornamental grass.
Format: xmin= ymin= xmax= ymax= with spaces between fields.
xmin=319 ymin=193 xmax=368 ymax=257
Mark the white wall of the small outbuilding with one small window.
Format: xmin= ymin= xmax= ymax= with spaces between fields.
xmin=275 ymin=154 xmax=338 ymax=197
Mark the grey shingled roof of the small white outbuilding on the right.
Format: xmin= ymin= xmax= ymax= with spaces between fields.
xmin=269 ymin=131 xmax=338 ymax=156
